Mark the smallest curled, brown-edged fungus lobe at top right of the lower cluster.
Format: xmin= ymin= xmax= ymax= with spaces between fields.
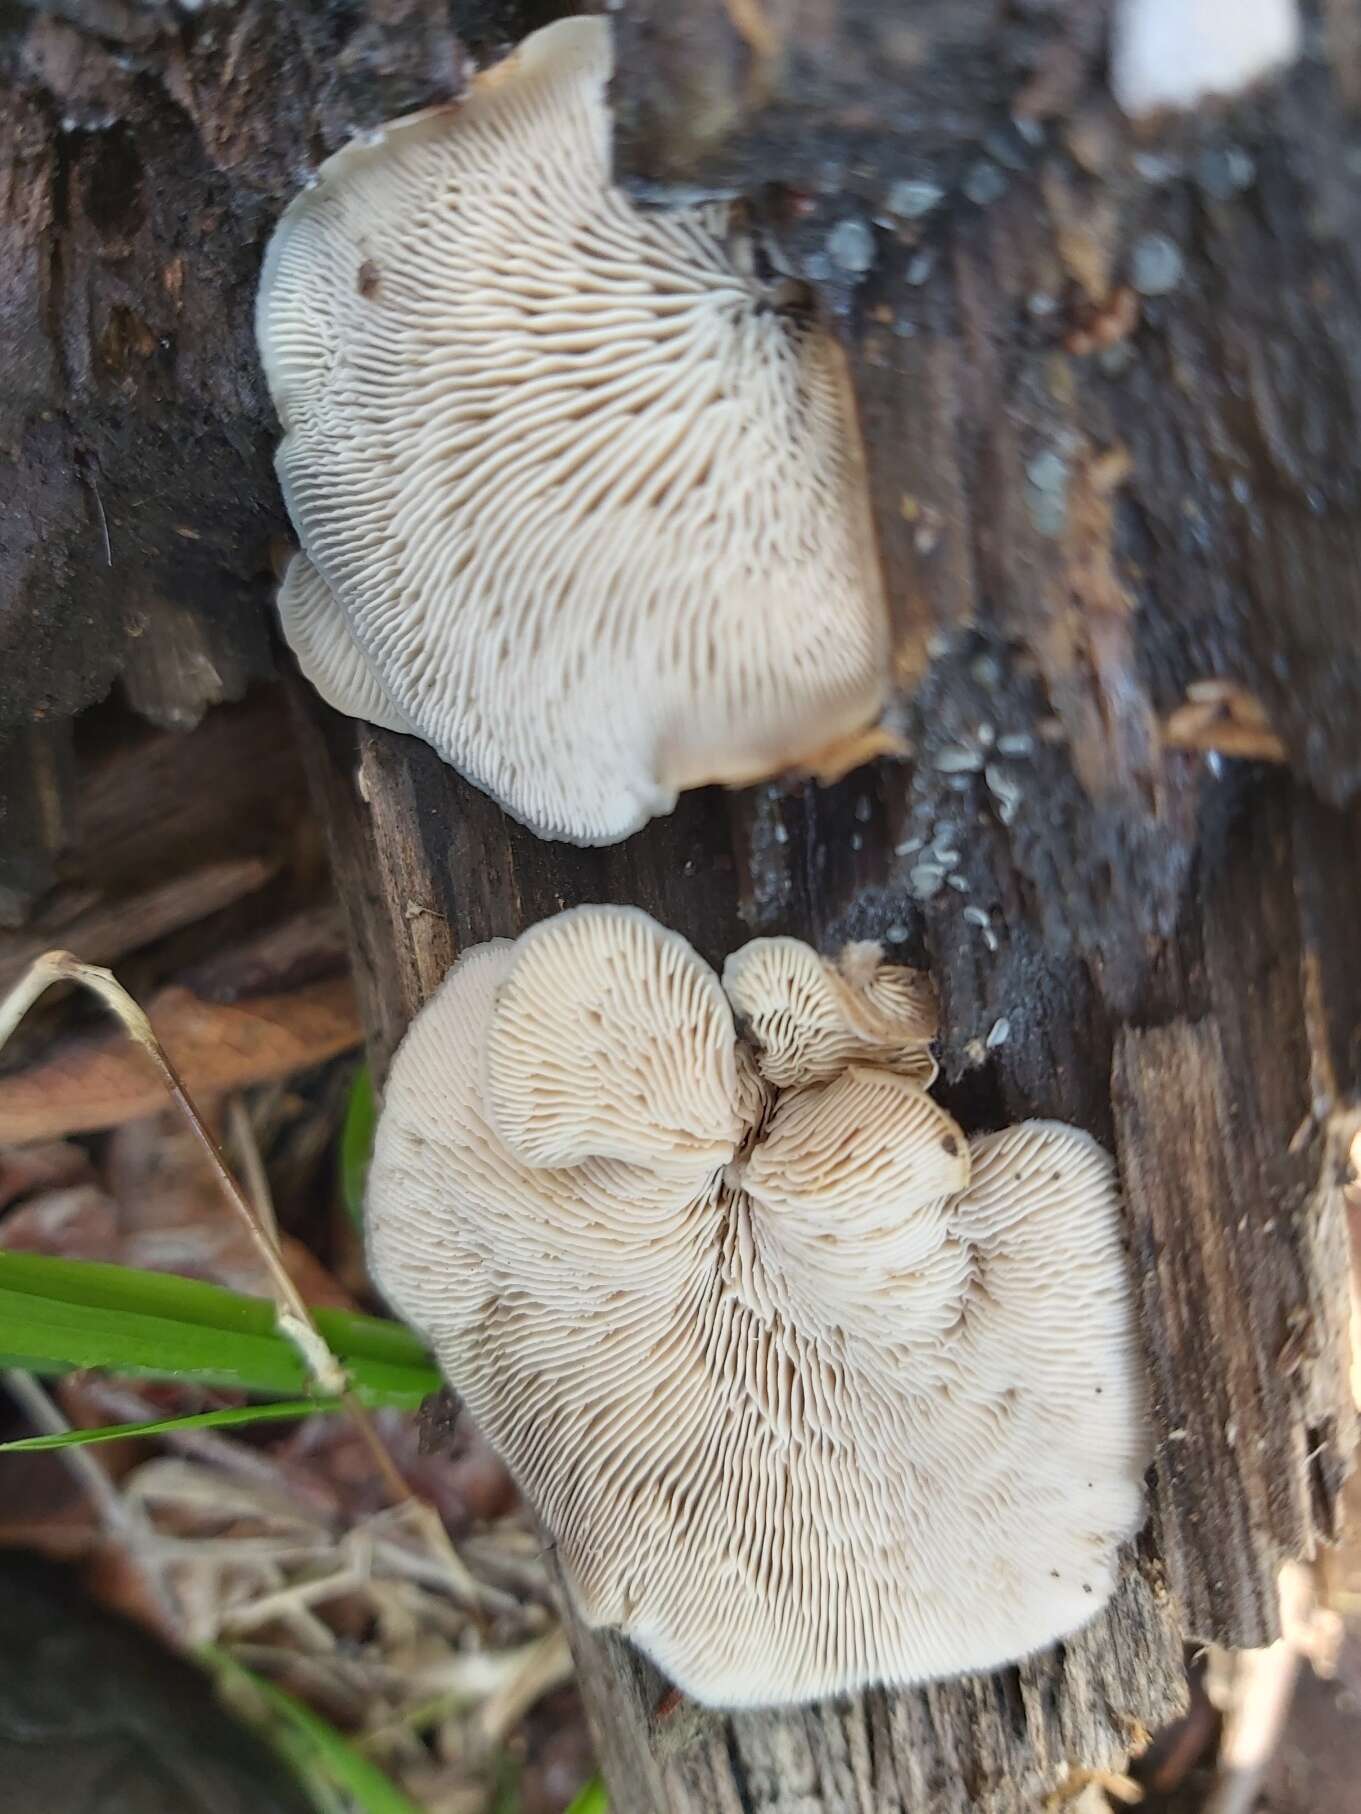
xmin=722 ymin=938 xmax=936 ymax=1088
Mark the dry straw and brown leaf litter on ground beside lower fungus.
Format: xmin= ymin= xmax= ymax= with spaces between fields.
xmin=0 ymin=957 xmax=592 ymax=1814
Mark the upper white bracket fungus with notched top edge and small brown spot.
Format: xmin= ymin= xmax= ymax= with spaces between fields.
xmin=256 ymin=18 xmax=887 ymax=844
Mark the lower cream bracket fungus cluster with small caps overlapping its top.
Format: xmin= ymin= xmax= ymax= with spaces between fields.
xmin=368 ymin=907 xmax=1149 ymax=1707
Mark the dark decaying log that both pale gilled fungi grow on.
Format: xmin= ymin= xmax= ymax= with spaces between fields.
xmin=0 ymin=0 xmax=1361 ymax=1814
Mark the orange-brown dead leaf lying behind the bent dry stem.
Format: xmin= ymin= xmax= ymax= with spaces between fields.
xmin=0 ymin=978 xmax=361 ymax=1145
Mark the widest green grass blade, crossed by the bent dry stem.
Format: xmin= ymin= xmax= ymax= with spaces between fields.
xmin=0 ymin=1253 xmax=439 ymax=1409
